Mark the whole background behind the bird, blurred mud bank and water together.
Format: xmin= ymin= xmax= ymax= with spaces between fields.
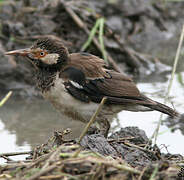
xmin=0 ymin=0 xmax=184 ymax=160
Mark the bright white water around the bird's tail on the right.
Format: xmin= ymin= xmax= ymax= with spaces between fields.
xmin=112 ymin=73 xmax=184 ymax=155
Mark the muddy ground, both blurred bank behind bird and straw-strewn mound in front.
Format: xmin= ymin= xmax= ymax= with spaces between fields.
xmin=0 ymin=0 xmax=184 ymax=180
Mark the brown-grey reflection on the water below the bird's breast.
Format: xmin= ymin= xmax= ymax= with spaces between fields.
xmin=0 ymin=98 xmax=84 ymax=147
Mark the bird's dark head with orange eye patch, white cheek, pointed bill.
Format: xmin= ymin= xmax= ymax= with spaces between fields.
xmin=6 ymin=38 xmax=68 ymax=70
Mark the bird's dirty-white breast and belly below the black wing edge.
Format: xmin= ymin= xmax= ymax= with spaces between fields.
xmin=43 ymin=75 xmax=98 ymax=122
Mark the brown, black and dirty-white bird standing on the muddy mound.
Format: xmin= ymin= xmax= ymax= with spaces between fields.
xmin=6 ymin=38 xmax=179 ymax=136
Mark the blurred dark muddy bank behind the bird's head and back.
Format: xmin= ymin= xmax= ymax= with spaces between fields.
xmin=0 ymin=0 xmax=184 ymax=97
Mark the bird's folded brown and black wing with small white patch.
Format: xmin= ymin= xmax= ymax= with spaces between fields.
xmin=60 ymin=53 xmax=152 ymax=104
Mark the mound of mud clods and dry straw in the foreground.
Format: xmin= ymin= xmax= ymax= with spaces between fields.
xmin=0 ymin=127 xmax=183 ymax=180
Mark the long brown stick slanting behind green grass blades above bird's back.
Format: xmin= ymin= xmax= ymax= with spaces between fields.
xmin=62 ymin=1 xmax=122 ymax=72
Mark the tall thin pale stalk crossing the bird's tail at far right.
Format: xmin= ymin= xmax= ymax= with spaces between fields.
xmin=153 ymin=25 xmax=184 ymax=144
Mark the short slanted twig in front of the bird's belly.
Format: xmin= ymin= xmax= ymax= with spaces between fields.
xmin=78 ymin=97 xmax=107 ymax=144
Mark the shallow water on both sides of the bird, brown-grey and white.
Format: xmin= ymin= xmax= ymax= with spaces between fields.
xmin=0 ymin=73 xmax=184 ymax=163
